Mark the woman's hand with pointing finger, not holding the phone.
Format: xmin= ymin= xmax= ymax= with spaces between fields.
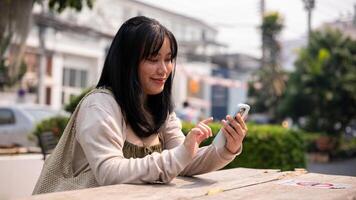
xmin=184 ymin=117 xmax=213 ymax=156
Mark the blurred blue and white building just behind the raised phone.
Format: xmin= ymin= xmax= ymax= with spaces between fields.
xmin=211 ymin=54 xmax=261 ymax=119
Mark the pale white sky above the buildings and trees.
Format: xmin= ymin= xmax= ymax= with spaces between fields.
xmin=140 ymin=0 xmax=356 ymax=56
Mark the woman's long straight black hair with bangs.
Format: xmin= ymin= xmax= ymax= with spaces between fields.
xmin=97 ymin=16 xmax=178 ymax=137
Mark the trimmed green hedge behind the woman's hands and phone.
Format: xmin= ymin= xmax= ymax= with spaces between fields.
xmin=182 ymin=123 xmax=306 ymax=170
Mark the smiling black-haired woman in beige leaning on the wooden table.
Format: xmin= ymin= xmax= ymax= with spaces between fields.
xmin=34 ymin=17 xmax=247 ymax=194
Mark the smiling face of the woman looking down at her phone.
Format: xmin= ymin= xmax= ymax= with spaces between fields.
xmin=138 ymin=37 xmax=173 ymax=95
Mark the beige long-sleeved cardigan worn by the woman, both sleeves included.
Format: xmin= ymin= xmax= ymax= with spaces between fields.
xmin=73 ymin=93 xmax=241 ymax=185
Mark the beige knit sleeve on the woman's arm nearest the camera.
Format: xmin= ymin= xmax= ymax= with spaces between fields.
xmin=76 ymin=93 xmax=192 ymax=185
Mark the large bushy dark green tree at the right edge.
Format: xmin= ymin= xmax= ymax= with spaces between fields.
xmin=279 ymin=29 xmax=356 ymax=135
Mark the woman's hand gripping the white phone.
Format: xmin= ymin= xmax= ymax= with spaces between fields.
xmin=221 ymin=114 xmax=247 ymax=154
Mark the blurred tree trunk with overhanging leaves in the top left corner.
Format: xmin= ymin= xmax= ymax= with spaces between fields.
xmin=0 ymin=0 xmax=93 ymax=89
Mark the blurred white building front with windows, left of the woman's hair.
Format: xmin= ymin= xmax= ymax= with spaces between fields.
xmin=23 ymin=13 xmax=112 ymax=108
